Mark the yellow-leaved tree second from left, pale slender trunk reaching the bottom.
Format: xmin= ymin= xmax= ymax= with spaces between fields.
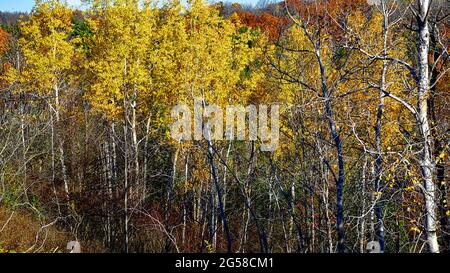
xmin=87 ymin=0 xmax=154 ymax=252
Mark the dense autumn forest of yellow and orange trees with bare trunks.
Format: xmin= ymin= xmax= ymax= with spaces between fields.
xmin=0 ymin=0 xmax=450 ymax=253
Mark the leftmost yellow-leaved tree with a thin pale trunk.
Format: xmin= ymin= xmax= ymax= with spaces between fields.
xmin=8 ymin=0 xmax=77 ymax=198
